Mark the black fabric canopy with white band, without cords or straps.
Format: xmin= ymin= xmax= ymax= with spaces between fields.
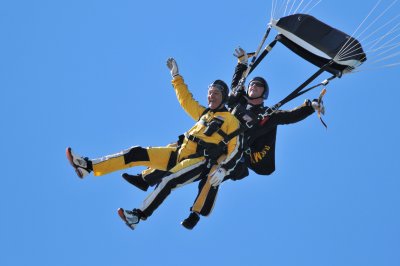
xmin=271 ymin=14 xmax=367 ymax=76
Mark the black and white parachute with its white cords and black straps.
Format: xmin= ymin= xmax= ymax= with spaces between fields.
xmin=245 ymin=0 xmax=400 ymax=115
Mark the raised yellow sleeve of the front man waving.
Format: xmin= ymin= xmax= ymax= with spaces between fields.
xmin=172 ymin=75 xmax=206 ymax=121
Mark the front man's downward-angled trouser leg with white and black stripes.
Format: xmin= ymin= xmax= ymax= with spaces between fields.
xmin=140 ymin=157 xmax=206 ymax=217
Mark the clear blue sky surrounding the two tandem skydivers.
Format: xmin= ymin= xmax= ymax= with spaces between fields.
xmin=0 ymin=0 xmax=400 ymax=266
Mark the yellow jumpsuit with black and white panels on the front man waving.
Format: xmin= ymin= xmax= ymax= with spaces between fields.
xmin=92 ymin=75 xmax=242 ymax=217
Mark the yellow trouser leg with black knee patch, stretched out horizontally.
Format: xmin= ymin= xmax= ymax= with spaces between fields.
xmin=91 ymin=146 xmax=176 ymax=176
